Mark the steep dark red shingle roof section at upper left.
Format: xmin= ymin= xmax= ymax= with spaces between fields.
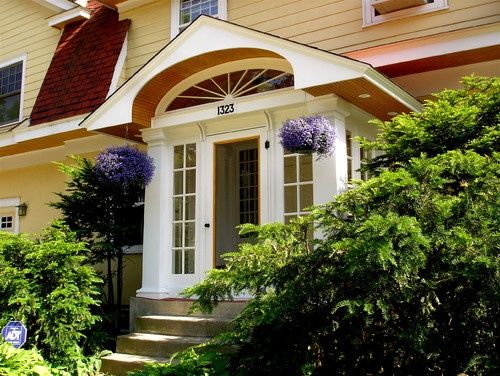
xmin=31 ymin=0 xmax=130 ymax=125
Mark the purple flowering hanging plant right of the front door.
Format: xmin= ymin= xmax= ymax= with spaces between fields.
xmin=278 ymin=115 xmax=335 ymax=157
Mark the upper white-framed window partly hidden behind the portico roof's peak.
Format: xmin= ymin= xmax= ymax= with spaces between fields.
xmin=171 ymin=0 xmax=227 ymax=38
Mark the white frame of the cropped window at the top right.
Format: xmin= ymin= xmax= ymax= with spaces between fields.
xmin=361 ymin=0 xmax=448 ymax=27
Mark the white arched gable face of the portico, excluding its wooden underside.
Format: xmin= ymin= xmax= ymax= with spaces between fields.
xmin=81 ymin=16 xmax=419 ymax=130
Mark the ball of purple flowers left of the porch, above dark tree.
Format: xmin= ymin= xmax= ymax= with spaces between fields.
xmin=95 ymin=145 xmax=154 ymax=187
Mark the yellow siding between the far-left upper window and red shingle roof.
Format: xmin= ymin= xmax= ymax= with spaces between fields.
xmin=0 ymin=0 xmax=60 ymax=120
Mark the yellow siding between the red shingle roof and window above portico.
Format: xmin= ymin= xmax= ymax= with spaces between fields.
xmin=120 ymin=0 xmax=170 ymax=78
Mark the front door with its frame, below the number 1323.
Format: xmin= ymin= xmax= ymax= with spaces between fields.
xmin=204 ymin=130 xmax=268 ymax=269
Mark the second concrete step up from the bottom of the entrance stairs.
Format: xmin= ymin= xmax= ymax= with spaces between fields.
xmin=116 ymin=333 xmax=210 ymax=357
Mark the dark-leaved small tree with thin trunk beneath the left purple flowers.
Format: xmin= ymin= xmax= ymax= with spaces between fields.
xmin=51 ymin=157 xmax=144 ymax=306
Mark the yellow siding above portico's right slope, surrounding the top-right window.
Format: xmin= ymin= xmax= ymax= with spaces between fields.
xmin=228 ymin=0 xmax=500 ymax=53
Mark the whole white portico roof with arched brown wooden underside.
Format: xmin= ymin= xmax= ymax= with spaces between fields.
xmin=80 ymin=16 xmax=421 ymax=138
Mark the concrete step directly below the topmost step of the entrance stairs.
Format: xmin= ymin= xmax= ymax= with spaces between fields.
xmin=135 ymin=315 xmax=233 ymax=337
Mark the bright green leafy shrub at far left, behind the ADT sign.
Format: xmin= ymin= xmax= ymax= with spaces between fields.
xmin=0 ymin=223 xmax=101 ymax=373
